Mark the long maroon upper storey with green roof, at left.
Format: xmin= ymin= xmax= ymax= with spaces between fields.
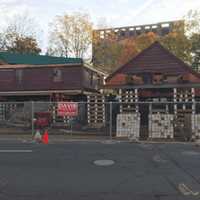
xmin=0 ymin=52 xmax=103 ymax=101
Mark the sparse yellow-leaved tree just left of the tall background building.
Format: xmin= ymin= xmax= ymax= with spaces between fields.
xmin=47 ymin=13 xmax=92 ymax=58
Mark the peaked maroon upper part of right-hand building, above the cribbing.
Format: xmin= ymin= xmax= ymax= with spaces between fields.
xmin=106 ymin=42 xmax=200 ymax=93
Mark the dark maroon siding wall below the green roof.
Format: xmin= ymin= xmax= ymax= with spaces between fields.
xmin=0 ymin=65 xmax=99 ymax=92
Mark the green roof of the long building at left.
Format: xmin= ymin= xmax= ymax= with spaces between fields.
xmin=0 ymin=52 xmax=83 ymax=65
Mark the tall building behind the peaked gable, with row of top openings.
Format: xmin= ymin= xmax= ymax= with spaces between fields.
xmin=92 ymin=21 xmax=184 ymax=73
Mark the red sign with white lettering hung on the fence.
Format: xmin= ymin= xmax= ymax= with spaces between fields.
xmin=57 ymin=102 xmax=78 ymax=117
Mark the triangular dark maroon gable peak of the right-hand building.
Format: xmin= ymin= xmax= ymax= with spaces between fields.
xmin=106 ymin=42 xmax=200 ymax=81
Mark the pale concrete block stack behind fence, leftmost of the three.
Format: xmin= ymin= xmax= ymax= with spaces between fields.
xmin=117 ymin=113 xmax=140 ymax=139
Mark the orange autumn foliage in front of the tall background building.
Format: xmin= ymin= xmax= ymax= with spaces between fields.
xmin=93 ymin=32 xmax=157 ymax=73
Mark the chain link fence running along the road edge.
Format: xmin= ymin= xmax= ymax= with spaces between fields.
xmin=0 ymin=102 xmax=200 ymax=141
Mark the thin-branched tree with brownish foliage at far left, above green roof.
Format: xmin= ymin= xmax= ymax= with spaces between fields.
xmin=0 ymin=14 xmax=41 ymax=54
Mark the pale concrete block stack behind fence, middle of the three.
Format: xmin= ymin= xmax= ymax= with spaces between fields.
xmin=149 ymin=113 xmax=174 ymax=139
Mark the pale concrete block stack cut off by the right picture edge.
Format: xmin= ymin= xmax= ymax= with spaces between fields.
xmin=191 ymin=114 xmax=200 ymax=139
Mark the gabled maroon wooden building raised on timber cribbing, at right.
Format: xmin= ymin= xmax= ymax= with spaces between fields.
xmin=104 ymin=42 xmax=200 ymax=138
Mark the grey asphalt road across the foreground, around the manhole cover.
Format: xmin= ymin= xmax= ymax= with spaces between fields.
xmin=0 ymin=141 xmax=200 ymax=200
